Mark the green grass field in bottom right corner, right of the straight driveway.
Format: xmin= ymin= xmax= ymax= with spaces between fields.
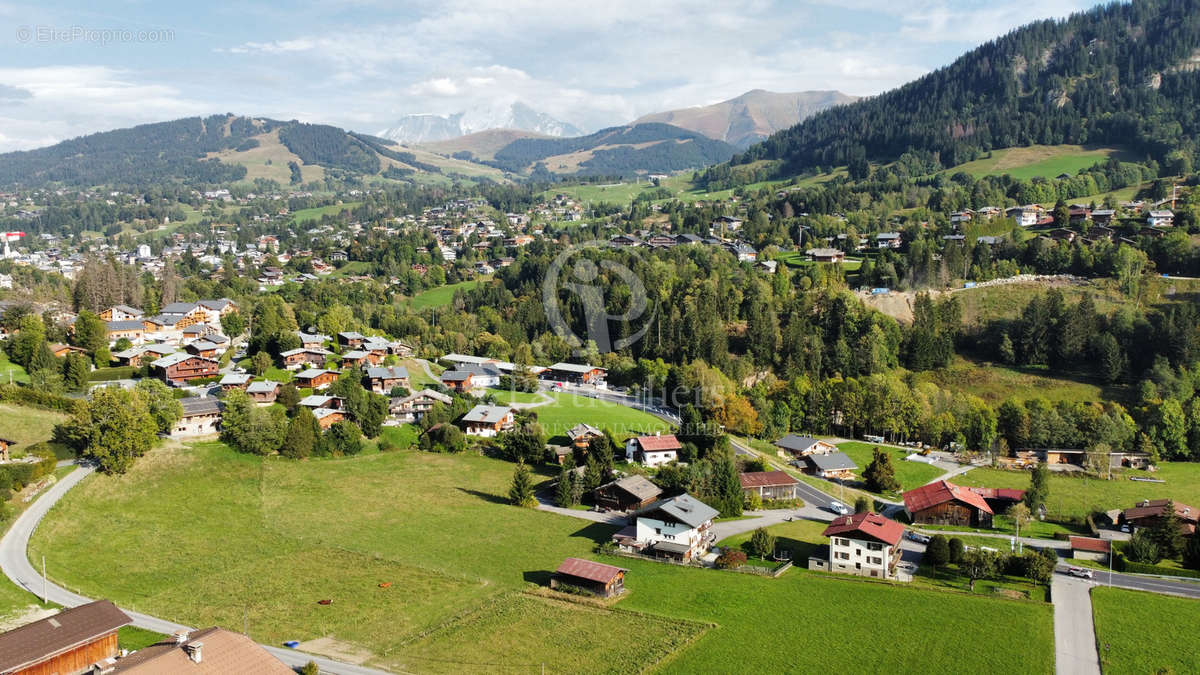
xmin=1092 ymin=586 xmax=1200 ymax=674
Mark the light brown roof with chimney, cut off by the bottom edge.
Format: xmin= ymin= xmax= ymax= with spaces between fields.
xmin=108 ymin=626 xmax=295 ymax=675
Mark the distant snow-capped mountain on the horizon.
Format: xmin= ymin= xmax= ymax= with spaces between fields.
xmin=376 ymin=101 xmax=583 ymax=143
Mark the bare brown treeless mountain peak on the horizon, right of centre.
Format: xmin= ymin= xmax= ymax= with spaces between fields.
xmin=632 ymin=89 xmax=858 ymax=149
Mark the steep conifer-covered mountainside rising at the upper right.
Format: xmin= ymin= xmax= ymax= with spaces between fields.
xmin=734 ymin=0 xmax=1200 ymax=173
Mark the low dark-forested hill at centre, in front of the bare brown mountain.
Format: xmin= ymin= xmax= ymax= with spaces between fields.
xmin=488 ymin=124 xmax=734 ymax=175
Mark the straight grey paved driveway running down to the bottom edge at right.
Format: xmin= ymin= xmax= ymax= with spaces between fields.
xmin=1050 ymin=572 xmax=1100 ymax=675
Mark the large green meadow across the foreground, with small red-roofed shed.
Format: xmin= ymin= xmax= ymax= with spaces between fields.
xmin=30 ymin=442 xmax=1054 ymax=673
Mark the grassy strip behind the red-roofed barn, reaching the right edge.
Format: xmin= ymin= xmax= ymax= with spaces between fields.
xmin=954 ymin=461 xmax=1200 ymax=516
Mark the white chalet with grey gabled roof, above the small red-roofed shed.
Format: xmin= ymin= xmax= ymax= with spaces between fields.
xmin=612 ymin=494 xmax=718 ymax=562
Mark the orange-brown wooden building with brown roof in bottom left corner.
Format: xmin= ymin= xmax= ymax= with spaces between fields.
xmin=0 ymin=601 xmax=133 ymax=675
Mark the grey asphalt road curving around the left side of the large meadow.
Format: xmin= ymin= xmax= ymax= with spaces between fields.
xmin=0 ymin=466 xmax=386 ymax=675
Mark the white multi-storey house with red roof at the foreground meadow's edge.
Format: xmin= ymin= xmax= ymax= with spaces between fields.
xmin=809 ymin=513 xmax=905 ymax=579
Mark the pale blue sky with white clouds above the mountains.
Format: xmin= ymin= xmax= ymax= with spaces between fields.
xmin=0 ymin=0 xmax=1092 ymax=151
